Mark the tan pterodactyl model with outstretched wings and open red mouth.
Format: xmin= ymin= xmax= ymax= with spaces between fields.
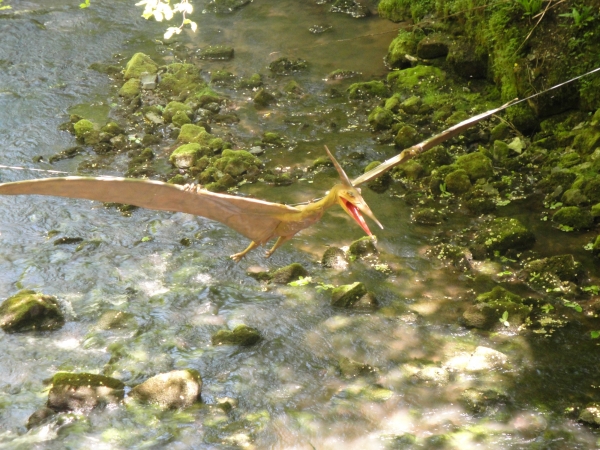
xmin=0 ymin=104 xmax=508 ymax=262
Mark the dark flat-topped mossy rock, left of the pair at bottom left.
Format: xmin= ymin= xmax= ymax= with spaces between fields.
xmin=47 ymin=372 xmax=125 ymax=411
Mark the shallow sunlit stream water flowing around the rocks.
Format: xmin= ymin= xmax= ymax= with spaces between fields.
xmin=0 ymin=0 xmax=599 ymax=449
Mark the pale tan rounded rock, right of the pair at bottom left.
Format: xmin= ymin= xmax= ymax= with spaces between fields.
xmin=129 ymin=369 xmax=202 ymax=409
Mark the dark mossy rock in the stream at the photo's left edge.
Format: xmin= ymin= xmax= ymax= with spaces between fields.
xmin=0 ymin=290 xmax=65 ymax=333
